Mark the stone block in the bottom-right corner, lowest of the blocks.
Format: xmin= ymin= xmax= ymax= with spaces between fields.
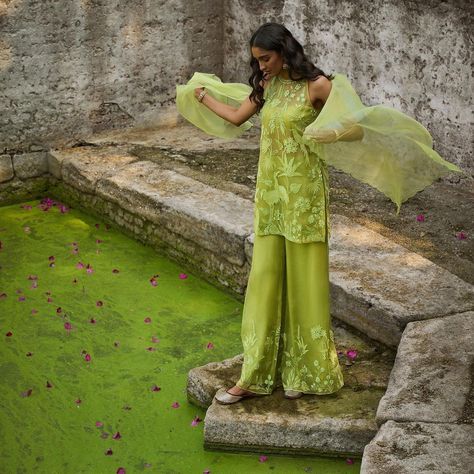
xmin=360 ymin=421 xmax=474 ymax=474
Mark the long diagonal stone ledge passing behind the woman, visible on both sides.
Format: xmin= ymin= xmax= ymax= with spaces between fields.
xmin=49 ymin=146 xmax=474 ymax=348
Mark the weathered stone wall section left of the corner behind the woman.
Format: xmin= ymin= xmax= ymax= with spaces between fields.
xmin=0 ymin=0 xmax=223 ymax=153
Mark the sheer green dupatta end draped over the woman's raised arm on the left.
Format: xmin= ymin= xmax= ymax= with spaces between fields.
xmin=176 ymin=72 xmax=253 ymax=138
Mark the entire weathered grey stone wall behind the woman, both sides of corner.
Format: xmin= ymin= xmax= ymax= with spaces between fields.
xmin=0 ymin=0 xmax=474 ymax=181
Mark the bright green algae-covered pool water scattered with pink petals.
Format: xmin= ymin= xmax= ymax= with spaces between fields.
xmin=0 ymin=199 xmax=360 ymax=474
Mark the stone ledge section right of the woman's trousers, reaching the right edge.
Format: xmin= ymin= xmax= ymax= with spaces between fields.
xmin=329 ymin=215 xmax=474 ymax=347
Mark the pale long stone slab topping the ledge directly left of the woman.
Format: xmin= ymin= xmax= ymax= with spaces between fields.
xmin=97 ymin=161 xmax=253 ymax=266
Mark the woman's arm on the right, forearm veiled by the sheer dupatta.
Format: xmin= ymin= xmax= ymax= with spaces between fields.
xmin=309 ymin=76 xmax=364 ymax=143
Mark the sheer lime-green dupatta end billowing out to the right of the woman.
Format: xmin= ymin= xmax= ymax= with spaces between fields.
xmin=303 ymin=74 xmax=463 ymax=215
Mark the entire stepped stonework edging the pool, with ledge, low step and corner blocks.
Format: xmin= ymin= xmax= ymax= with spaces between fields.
xmin=0 ymin=131 xmax=474 ymax=473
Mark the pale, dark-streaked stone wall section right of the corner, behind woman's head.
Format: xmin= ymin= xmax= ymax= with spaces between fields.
xmin=223 ymin=0 xmax=474 ymax=181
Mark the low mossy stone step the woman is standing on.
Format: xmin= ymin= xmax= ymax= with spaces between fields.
xmin=187 ymin=321 xmax=395 ymax=457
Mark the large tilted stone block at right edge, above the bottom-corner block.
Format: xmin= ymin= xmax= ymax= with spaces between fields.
xmin=377 ymin=311 xmax=474 ymax=426
